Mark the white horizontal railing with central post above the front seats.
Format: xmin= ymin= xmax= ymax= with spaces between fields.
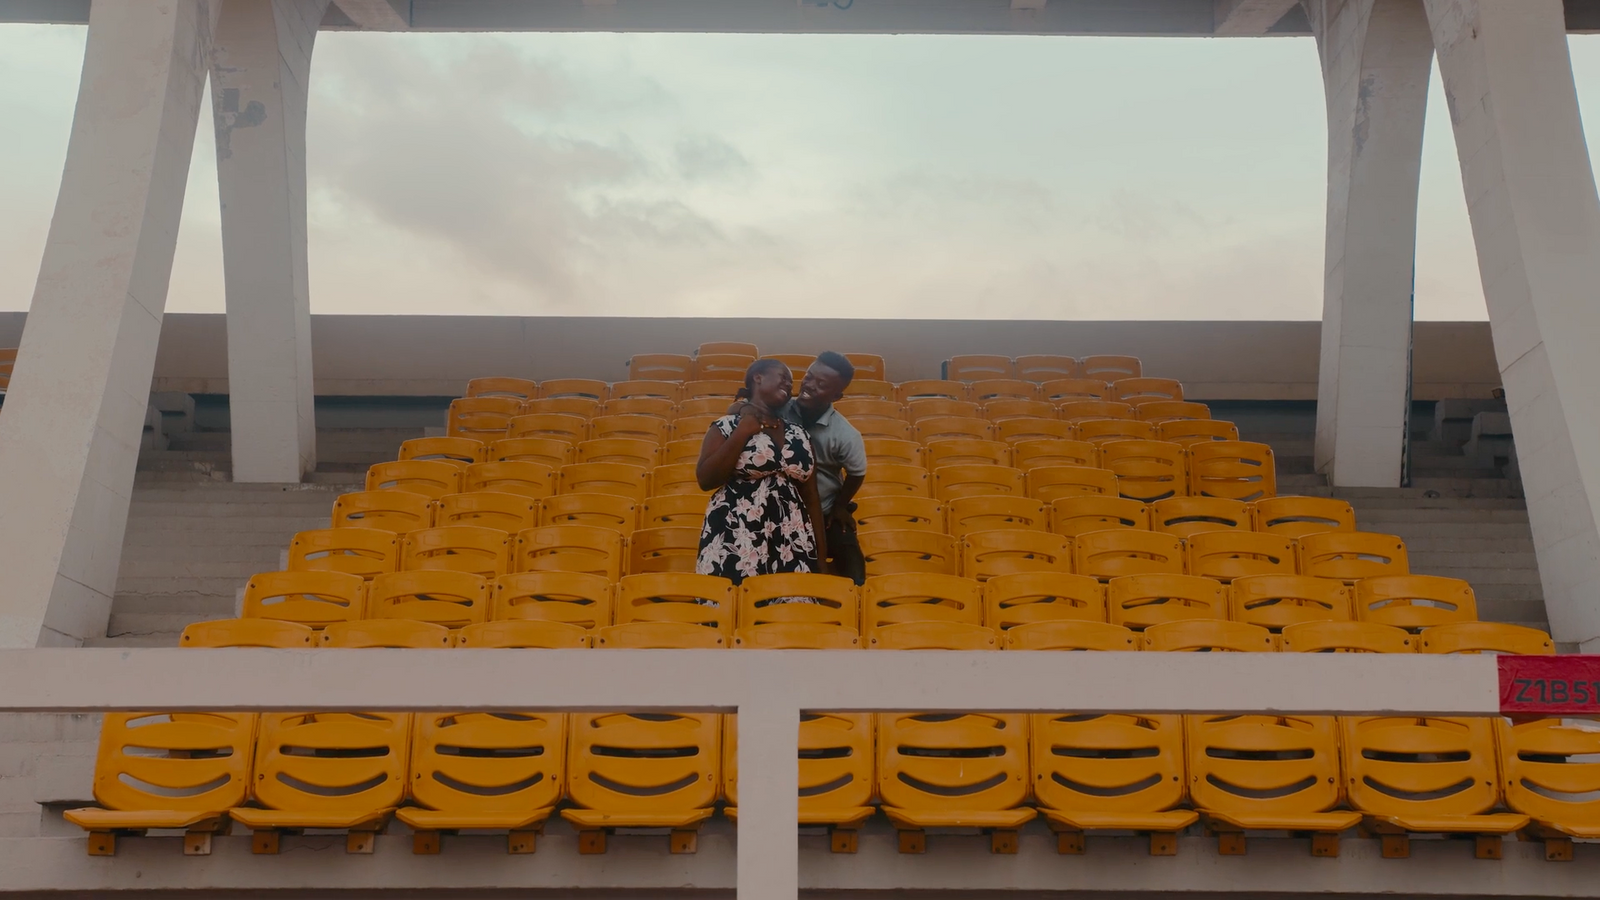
xmin=0 ymin=649 xmax=1499 ymax=900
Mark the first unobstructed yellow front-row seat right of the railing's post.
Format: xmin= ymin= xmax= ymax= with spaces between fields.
xmin=877 ymin=713 xmax=1035 ymax=854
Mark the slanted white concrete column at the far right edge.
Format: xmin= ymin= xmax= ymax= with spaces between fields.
xmin=1427 ymin=0 xmax=1600 ymax=643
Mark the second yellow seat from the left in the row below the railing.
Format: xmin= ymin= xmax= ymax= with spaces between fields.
xmin=229 ymin=711 xmax=419 ymax=854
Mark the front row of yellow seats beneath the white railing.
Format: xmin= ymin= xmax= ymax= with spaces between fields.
xmin=66 ymin=701 xmax=1600 ymax=858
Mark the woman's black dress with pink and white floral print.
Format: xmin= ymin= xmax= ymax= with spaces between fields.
xmin=694 ymin=416 xmax=819 ymax=585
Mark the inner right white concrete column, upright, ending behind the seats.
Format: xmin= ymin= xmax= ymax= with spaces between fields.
xmin=1307 ymin=0 xmax=1434 ymax=487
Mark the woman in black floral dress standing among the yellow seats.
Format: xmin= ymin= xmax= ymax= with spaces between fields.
xmin=694 ymin=359 xmax=827 ymax=585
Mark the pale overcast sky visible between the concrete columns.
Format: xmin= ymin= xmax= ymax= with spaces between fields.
xmin=0 ymin=26 xmax=1600 ymax=319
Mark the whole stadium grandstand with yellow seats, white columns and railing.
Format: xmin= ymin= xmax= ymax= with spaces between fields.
xmin=0 ymin=0 xmax=1600 ymax=900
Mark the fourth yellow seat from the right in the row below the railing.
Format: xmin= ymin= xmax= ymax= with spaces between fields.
xmin=1029 ymin=713 xmax=1198 ymax=857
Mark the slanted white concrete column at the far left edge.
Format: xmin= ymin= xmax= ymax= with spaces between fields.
xmin=0 ymin=0 xmax=211 ymax=647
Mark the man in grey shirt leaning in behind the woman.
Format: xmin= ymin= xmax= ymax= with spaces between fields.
xmin=782 ymin=351 xmax=867 ymax=585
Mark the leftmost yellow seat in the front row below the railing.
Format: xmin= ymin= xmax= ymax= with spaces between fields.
xmin=64 ymin=713 xmax=259 ymax=857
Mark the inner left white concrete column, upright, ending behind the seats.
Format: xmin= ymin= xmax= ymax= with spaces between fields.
xmin=211 ymin=0 xmax=328 ymax=482
